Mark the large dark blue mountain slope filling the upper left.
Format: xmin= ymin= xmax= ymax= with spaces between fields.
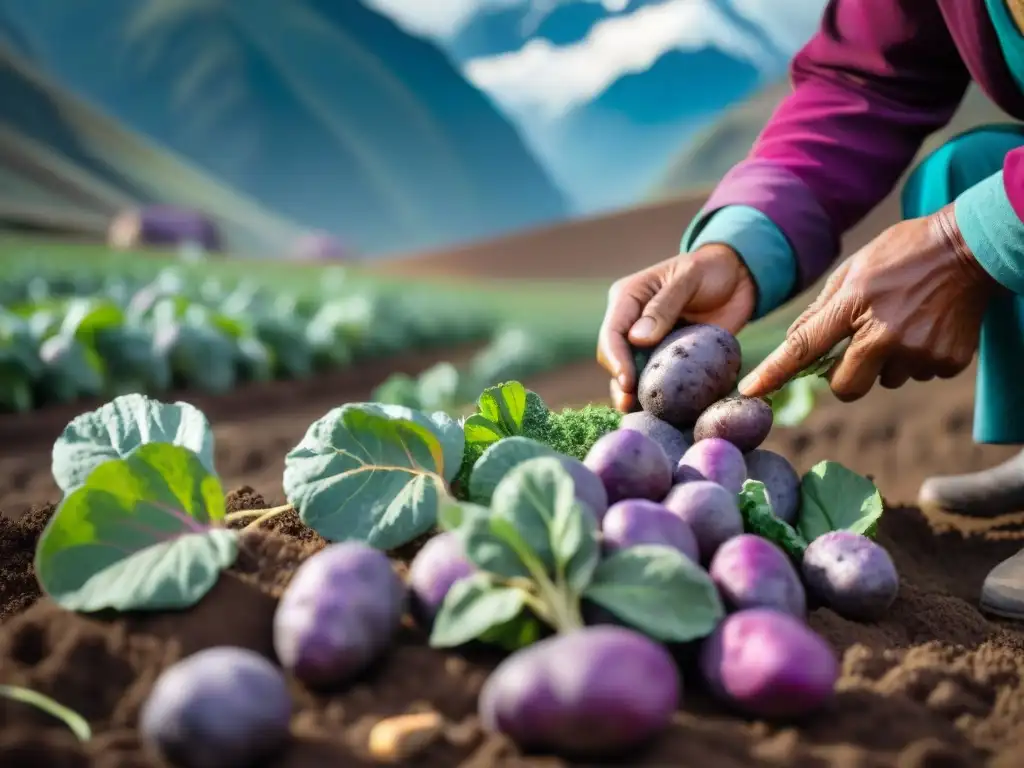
xmin=0 ymin=0 xmax=568 ymax=259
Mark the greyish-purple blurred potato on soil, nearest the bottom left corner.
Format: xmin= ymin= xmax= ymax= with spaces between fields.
xmin=138 ymin=646 xmax=292 ymax=768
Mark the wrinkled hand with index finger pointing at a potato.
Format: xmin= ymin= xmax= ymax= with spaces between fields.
xmin=739 ymin=205 xmax=997 ymax=401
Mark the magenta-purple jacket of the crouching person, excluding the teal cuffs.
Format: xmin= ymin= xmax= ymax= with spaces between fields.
xmin=705 ymin=0 xmax=1024 ymax=288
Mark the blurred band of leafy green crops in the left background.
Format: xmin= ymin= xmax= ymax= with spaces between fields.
xmin=0 ymin=268 xmax=593 ymax=412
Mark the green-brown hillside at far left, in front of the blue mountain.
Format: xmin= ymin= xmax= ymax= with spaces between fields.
xmin=0 ymin=42 xmax=299 ymax=255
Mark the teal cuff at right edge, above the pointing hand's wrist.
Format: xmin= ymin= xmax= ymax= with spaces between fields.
xmin=953 ymin=171 xmax=1024 ymax=296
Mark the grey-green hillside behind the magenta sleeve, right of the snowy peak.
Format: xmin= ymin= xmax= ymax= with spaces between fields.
xmin=648 ymin=82 xmax=1011 ymax=200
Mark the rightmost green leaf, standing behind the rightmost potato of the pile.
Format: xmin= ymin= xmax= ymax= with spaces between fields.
xmin=798 ymin=462 xmax=882 ymax=542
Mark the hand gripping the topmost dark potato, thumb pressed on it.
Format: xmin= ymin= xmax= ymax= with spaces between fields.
xmin=597 ymin=244 xmax=757 ymax=411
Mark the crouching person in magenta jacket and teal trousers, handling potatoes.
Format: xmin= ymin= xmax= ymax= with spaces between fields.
xmin=598 ymin=0 xmax=1024 ymax=617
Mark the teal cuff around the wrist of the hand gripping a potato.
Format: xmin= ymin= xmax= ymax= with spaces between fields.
xmin=681 ymin=205 xmax=797 ymax=319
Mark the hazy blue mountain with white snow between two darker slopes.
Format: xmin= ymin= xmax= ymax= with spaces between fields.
xmin=364 ymin=0 xmax=825 ymax=212
